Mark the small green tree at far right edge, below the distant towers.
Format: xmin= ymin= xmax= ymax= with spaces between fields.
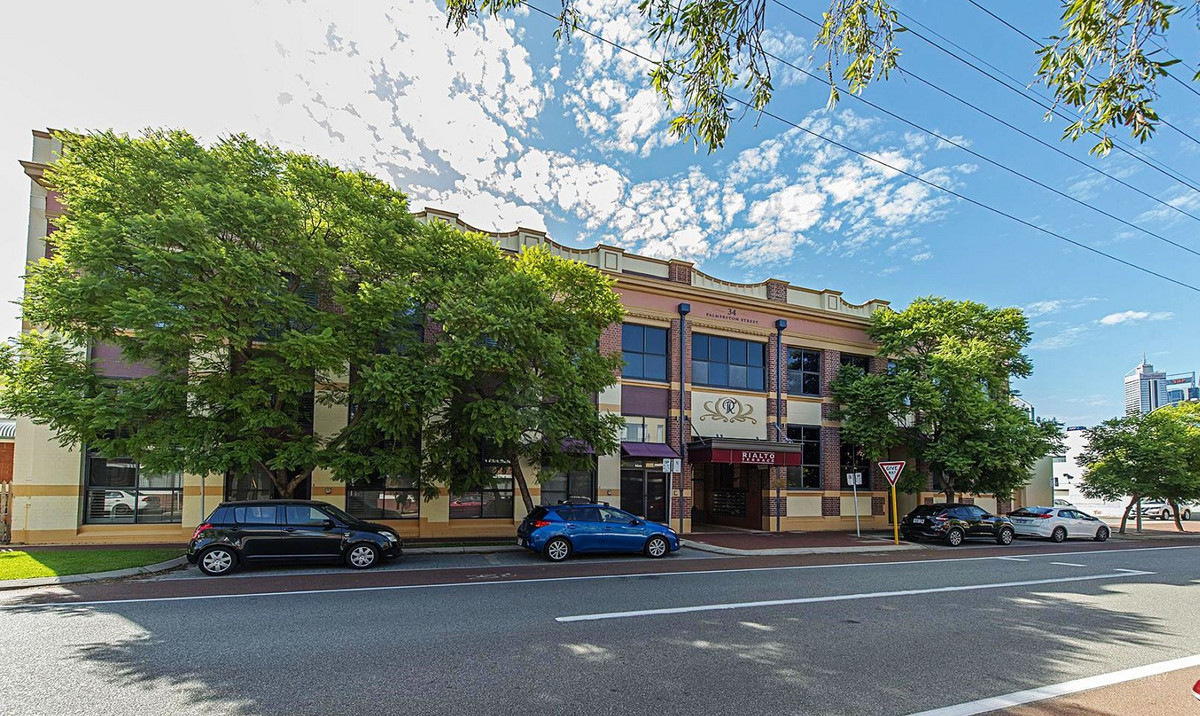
xmin=1076 ymin=404 xmax=1200 ymax=533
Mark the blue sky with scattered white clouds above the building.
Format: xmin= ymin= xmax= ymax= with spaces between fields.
xmin=0 ymin=0 xmax=1200 ymax=425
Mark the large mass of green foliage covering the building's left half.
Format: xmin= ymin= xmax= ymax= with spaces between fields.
xmin=0 ymin=132 xmax=620 ymax=506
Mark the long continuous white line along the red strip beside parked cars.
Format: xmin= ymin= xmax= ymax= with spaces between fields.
xmin=0 ymin=544 xmax=1200 ymax=612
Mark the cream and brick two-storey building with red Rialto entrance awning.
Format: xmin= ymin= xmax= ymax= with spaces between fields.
xmin=12 ymin=132 xmax=1012 ymax=542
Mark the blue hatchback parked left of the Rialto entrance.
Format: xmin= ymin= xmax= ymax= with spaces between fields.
xmin=517 ymin=503 xmax=679 ymax=561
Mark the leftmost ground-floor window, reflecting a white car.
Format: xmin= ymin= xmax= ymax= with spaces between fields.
xmin=83 ymin=450 xmax=184 ymax=524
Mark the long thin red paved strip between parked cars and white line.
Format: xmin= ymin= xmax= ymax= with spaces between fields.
xmin=0 ymin=540 xmax=1200 ymax=606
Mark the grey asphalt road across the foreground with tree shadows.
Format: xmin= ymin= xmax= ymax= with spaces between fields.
xmin=0 ymin=542 xmax=1200 ymax=716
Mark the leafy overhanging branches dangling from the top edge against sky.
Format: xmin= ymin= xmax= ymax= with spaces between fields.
xmin=446 ymin=0 xmax=1200 ymax=154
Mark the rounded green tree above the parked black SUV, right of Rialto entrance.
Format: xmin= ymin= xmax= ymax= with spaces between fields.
xmin=832 ymin=297 xmax=1062 ymax=501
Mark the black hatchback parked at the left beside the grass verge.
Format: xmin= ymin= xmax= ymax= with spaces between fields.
xmin=187 ymin=500 xmax=401 ymax=577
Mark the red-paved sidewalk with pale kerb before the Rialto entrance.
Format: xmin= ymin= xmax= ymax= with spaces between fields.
xmin=683 ymin=530 xmax=925 ymax=556
